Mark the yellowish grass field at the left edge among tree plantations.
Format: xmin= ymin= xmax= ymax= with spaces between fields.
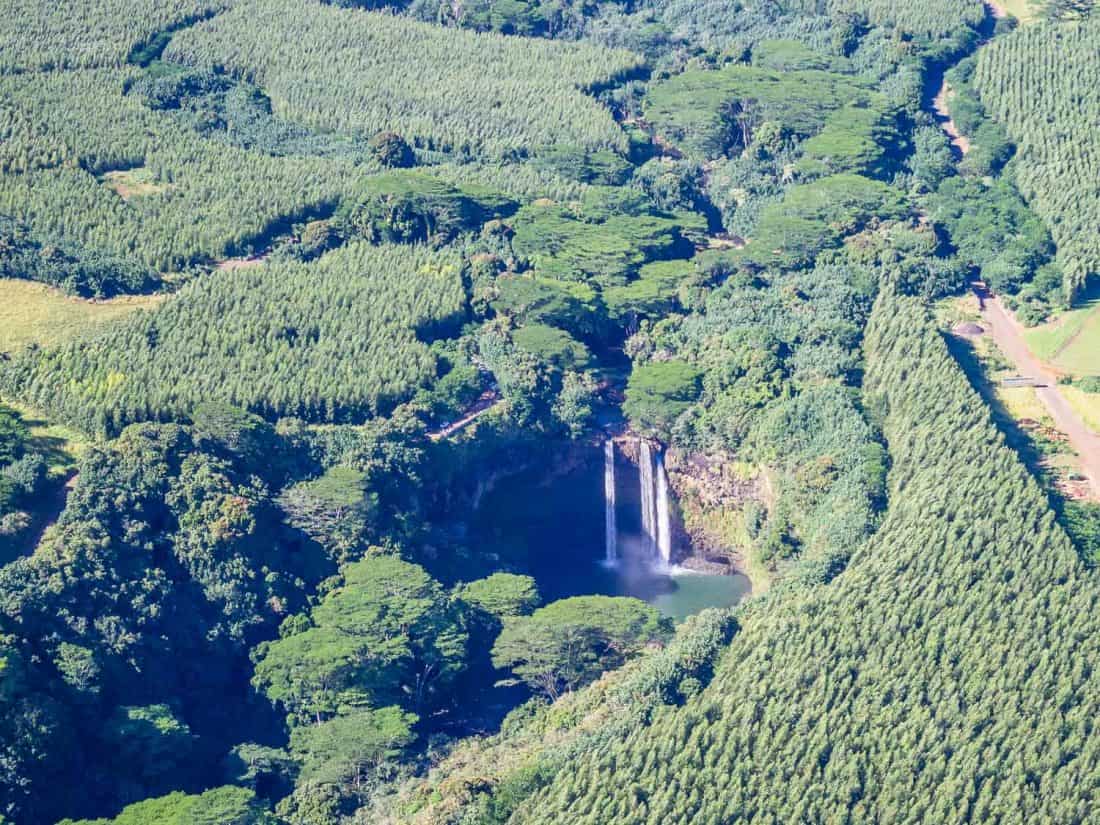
xmin=0 ymin=278 xmax=162 ymax=352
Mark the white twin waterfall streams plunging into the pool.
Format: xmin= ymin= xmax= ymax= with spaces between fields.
xmin=604 ymin=439 xmax=672 ymax=568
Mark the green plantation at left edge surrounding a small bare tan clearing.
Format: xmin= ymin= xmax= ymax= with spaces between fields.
xmin=0 ymin=67 xmax=360 ymax=271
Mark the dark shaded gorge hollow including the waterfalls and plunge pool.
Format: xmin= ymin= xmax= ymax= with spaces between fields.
xmin=471 ymin=435 xmax=750 ymax=620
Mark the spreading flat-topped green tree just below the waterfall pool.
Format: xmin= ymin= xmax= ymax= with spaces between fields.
xmin=493 ymin=596 xmax=671 ymax=699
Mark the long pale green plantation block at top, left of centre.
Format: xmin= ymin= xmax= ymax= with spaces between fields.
xmin=165 ymin=0 xmax=638 ymax=154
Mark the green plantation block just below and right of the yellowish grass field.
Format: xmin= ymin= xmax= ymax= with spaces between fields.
xmin=6 ymin=243 xmax=464 ymax=431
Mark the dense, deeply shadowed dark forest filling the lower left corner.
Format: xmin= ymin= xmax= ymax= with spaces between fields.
xmin=0 ymin=415 xmax=333 ymax=821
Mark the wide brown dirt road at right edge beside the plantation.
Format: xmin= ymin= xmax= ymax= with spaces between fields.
xmin=975 ymin=287 xmax=1100 ymax=499
